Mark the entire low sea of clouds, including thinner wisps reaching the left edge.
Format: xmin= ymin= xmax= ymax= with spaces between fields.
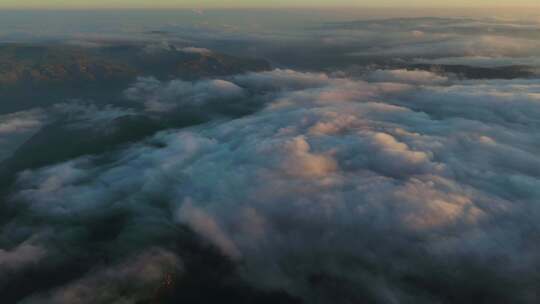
xmin=0 ymin=69 xmax=540 ymax=304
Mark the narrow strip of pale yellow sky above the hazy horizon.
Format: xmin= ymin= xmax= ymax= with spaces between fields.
xmin=0 ymin=0 xmax=540 ymax=9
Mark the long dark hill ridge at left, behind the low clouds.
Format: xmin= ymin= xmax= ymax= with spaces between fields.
xmin=0 ymin=44 xmax=270 ymax=113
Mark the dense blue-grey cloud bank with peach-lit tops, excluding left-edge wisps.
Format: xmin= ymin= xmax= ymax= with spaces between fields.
xmin=7 ymin=70 xmax=540 ymax=303
